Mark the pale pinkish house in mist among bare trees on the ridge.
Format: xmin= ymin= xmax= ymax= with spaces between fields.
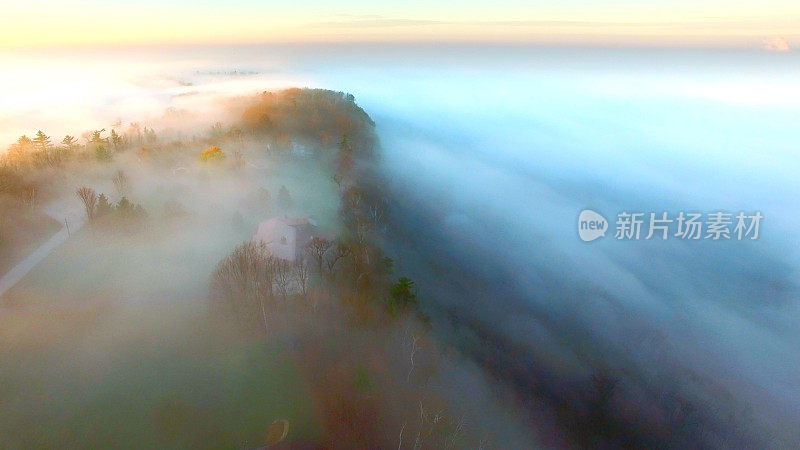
xmin=253 ymin=216 xmax=317 ymax=262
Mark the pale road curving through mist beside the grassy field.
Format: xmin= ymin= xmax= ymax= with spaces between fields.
xmin=0 ymin=199 xmax=86 ymax=297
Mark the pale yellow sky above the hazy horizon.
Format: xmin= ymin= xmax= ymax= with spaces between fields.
xmin=0 ymin=0 xmax=800 ymax=48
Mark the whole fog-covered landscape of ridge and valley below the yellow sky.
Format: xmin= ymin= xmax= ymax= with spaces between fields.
xmin=0 ymin=45 xmax=800 ymax=449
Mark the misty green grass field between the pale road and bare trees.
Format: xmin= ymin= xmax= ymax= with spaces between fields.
xmin=0 ymin=219 xmax=319 ymax=448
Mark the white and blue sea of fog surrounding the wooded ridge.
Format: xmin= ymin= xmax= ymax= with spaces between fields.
xmin=0 ymin=45 xmax=800 ymax=444
